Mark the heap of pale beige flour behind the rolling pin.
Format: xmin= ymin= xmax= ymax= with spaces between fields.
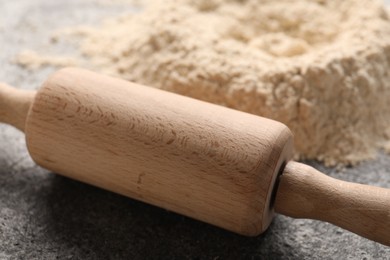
xmin=29 ymin=0 xmax=390 ymax=165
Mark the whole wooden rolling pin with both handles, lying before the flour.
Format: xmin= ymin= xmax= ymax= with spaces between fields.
xmin=0 ymin=68 xmax=390 ymax=246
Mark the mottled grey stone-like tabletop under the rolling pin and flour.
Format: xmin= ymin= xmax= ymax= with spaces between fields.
xmin=0 ymin=0 xmax=390 ymax=259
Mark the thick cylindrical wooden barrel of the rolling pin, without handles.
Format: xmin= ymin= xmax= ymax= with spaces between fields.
xmin=25 ymin=69 xmax=292 ymax=235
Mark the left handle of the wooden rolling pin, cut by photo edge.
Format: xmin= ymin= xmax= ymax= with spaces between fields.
xmin=0 ymin=83 xmax=36 ymax=132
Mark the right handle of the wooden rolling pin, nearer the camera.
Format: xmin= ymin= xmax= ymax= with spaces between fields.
xmin=275 ymin=162 xmax=390 ymax=246
